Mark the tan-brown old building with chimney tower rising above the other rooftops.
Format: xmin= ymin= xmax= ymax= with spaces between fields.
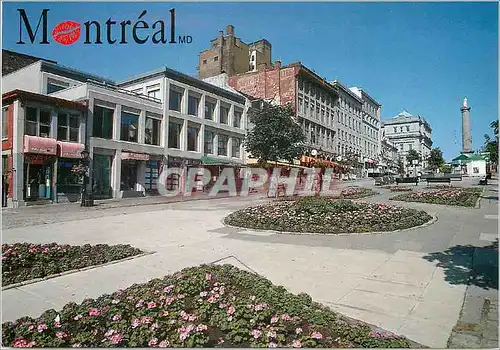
xmin=198 ymin=25 xmax=271 ymax=79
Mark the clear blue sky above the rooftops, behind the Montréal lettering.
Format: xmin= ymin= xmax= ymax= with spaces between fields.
xmin=3 ymin=2 xmax=498 ymax=159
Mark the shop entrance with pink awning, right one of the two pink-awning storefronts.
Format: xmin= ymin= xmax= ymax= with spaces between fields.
xmin=54 ymin=141 xmax=85 ymax=203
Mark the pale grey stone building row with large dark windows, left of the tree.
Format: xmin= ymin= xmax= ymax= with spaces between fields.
xmin=3 ymin=50 xmax=248 ymax=206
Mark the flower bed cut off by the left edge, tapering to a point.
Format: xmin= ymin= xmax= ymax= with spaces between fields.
xmin=2 ymin=243 xmax=142 ymax=286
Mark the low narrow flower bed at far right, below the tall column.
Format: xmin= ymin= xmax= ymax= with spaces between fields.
xmin=391 ymin=187 xmax=482 ymax=207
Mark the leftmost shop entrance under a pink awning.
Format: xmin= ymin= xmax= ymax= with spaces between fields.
xmin=23 ymin=135 xmax=57 ymax=201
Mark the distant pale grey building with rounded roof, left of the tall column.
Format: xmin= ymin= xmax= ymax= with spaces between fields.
xmin=383 ymin=110 xmax=433 ymax=175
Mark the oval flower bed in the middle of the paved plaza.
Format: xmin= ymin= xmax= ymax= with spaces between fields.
xmin=224 ymin=197 xmax=432 ymax=234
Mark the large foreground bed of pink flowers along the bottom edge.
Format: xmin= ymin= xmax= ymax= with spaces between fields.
xmin=2 ymin=265 xmax=422 ymax=348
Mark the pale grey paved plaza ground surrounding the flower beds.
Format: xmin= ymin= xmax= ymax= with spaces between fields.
xmin=2 ymin=181 xmax=498 ymax=348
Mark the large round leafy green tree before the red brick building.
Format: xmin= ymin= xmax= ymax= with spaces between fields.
xmin=245 ymin=102 xmax=305 ymax=163
